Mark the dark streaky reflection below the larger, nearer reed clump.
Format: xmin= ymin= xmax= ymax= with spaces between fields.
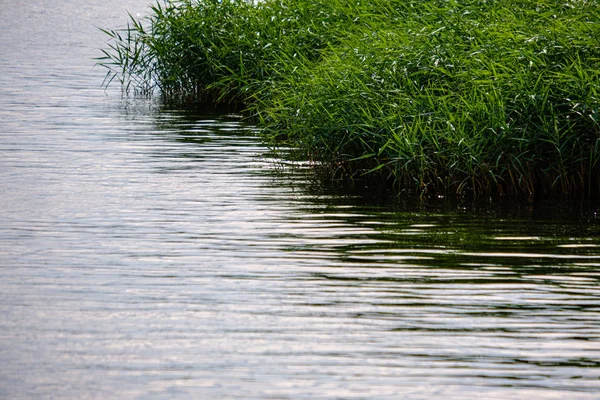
xmin=116 ymin=110 xmax=600 ymax=396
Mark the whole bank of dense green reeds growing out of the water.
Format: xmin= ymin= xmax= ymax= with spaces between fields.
xmin=101 ymin=0 xmax=600 ymax=197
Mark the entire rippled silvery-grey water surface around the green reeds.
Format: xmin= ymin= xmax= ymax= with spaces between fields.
xmin=0 ymin=0 xmax=600 ymax=399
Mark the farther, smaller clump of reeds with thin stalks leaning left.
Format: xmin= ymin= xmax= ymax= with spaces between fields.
xmin=99 ymin=0 xmax=366 ymax=104
